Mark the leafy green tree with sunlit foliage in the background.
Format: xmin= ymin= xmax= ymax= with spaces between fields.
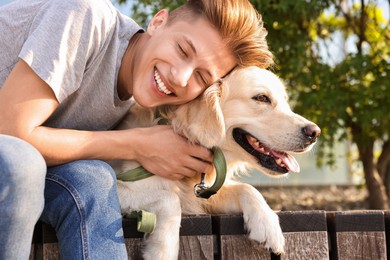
xmin=118 ymin=0 xmax=390 ymax=209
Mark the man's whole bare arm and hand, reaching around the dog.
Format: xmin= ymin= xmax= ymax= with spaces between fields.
xmin=0 ymin=60 xmax=212 ymax=179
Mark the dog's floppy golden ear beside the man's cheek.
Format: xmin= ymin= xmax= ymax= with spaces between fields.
xmin=171 ymin=82 xmax=225 ymax=148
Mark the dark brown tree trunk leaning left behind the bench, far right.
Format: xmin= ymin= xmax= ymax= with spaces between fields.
xmin=356 ymin=142 xmax=388 ymax=209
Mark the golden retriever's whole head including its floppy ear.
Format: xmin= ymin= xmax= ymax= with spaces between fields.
xmin=165 ymin=67 xmax=321 ymax=176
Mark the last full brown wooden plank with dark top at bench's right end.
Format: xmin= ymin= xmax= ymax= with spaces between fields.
xmin=327 ymin=211 xmax=386 ymax=260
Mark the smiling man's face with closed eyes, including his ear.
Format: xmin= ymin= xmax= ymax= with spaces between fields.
xmin=132 ymin=10 xmax=236 ymax=107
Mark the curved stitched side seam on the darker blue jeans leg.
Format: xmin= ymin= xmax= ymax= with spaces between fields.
xmin=46 ymin=173 xmax=90 ymax=260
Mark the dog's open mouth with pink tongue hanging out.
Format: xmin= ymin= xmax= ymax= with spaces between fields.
xmin=233 ymin=128 xmax=300 ymax=174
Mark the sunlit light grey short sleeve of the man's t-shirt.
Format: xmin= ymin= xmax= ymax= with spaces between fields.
xmin=19 ymin=0 xmax=116 ymax=102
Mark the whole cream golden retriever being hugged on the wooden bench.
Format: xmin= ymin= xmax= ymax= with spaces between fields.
xmin=109 ymin=67 xmax=320 ymax=260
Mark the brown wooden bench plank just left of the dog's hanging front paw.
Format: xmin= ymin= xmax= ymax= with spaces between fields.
xmin=212 ymin=215 xmax=271 ymax=260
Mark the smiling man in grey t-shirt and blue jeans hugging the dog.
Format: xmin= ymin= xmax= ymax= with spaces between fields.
xmin=0 ymin=0 xmax=272 ymax=259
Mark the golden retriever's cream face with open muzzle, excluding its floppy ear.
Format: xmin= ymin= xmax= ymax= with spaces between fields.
xmin=220 ymin=67 xmax=321 ymax=176
